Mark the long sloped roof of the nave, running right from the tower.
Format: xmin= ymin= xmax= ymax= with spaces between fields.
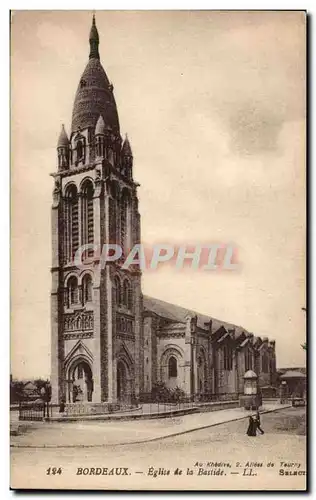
xmin=143 ymin=295 xmax=248 ymax=337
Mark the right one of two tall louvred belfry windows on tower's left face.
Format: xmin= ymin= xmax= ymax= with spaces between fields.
xmin=81 ymin=180 xmax=94 ymax=257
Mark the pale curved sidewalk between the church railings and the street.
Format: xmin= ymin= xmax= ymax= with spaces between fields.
xmin=11 ymin=403 xmax=290 ymax=448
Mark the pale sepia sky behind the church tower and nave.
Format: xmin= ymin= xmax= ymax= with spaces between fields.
xmin=11 ymin=11 xmax=306 ymax=378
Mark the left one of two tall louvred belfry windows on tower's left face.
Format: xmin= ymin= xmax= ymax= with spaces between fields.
xmin=64 ymin=185 xmax=79 ymax=262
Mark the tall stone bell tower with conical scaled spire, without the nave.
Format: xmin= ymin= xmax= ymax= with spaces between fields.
xmin=51 ymin=16 xmax=143 ymax=406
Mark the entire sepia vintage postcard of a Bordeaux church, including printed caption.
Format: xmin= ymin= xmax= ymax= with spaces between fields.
xmin=10 ymin=10 xmax=307 ymax=491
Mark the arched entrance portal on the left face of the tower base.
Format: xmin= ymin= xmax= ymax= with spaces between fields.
xmin=69 ymin=360 xmax=93 ymax=403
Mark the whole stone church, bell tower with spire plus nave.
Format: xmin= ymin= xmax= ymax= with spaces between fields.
xmin=51 ymin=18 xmax=276 ymax=403
